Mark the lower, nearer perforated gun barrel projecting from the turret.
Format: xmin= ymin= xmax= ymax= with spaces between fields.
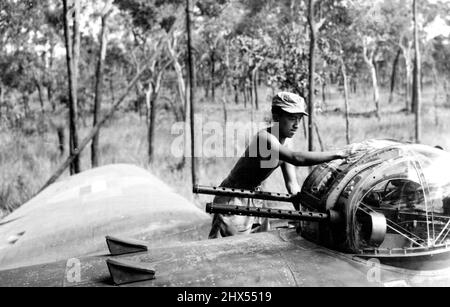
xmin=206 ymin=203 xmax=329 ymax=222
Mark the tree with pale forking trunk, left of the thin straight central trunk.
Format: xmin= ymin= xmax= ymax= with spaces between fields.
xmin=115 ymin=0 xmax=186 ymax=163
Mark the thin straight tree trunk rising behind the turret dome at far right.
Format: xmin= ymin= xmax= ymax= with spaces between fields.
xmin=413 ymin=0 xmax=422 ymax=143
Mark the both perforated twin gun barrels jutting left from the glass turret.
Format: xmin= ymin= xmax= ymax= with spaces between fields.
xmin=193 ymin=185 xmax=341 ymax=224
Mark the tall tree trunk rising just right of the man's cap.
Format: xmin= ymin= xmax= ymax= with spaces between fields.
xmin=308 ymin=0 xmax=316 ymax=151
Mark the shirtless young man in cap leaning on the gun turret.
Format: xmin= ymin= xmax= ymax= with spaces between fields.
xmin=209 ymin=92 xmax=349 ymax=239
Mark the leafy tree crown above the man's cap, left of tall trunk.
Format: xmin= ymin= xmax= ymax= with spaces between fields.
xmin=239 ymin=0 xmax=309 ymax=97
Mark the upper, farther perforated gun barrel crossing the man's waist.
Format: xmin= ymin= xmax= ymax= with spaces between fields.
xmin=193 ymin=185 xmax=295 ymax=202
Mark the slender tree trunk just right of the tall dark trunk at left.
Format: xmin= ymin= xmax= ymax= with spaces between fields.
xmin=91 ymin=8 xmax=109 ymax=168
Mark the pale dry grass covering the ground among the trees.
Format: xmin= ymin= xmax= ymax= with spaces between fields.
xmin=0 ymin=85 xmax=450 ymax=218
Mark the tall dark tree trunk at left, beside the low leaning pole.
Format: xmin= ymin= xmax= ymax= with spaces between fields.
xmin=63 ymin=0 xmax=81 ymax=175
